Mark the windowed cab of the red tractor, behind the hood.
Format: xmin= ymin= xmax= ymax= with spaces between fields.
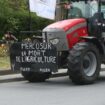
xmin=63 ymin=0 xmax=105 ymax=38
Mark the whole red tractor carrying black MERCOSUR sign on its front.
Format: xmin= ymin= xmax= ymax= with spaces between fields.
xmin=11 ymin=0 xmax=105 ymax=84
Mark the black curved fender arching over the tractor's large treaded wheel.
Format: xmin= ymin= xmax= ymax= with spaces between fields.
xmin=81 ymin=36 xmax=105 ymax=56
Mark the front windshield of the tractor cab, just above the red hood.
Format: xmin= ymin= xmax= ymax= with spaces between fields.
xmin=68 ymin=0 xmax=98 ymax=18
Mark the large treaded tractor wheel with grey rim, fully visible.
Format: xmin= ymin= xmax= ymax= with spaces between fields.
xmin=68 ymin=42 xmax=101 ymax=85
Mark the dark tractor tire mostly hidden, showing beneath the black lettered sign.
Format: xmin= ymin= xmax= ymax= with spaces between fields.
xmin=21 ymin=71 xmax=51 ymax=82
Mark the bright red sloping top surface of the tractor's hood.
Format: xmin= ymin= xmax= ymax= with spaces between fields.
xmin=45 ymin=18 xmax=86 ymax=31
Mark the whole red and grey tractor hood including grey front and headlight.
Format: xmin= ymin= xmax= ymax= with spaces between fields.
xmin=42 ymin=18 xmax=86 ymax=51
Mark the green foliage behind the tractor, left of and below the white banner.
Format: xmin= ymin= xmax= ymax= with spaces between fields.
xmin=0 ymin=0 xmax=52 ymax=37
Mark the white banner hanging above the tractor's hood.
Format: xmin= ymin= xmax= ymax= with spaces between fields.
xmin=29 ymin=0 xmax=56 ymax=19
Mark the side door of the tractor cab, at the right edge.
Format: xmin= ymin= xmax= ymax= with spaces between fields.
xmin=88 ymin=0 xmax=105 ymax=38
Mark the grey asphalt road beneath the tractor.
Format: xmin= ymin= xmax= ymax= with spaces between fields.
xmin=0 ymin=72 xmax=105 ymax=105
